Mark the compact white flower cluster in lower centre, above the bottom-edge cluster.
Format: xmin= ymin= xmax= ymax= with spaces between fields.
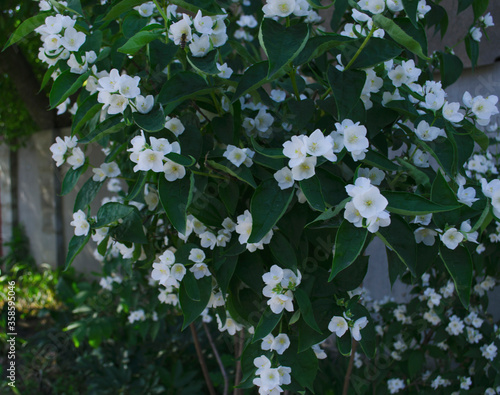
xmin=262 ymin=265 xmax=302 ymax=314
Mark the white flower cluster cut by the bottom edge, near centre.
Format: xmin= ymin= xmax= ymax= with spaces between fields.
xmin=253 ymin=355 xmax=292 ymax=395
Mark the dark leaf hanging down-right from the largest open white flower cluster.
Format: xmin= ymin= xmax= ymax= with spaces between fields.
xmin=377 ymin=215 xmax=417 ymax=276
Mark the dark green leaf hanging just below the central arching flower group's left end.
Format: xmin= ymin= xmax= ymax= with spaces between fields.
xmin=248 ymin=178 xmax=293 ymax=243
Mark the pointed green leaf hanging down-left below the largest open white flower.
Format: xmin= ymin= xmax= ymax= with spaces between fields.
xmin=328 ymin=220 xmax=368 ymax=281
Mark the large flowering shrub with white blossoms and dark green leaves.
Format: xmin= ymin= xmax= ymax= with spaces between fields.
xmin=4 ymin=0 xmax=500 ymax=394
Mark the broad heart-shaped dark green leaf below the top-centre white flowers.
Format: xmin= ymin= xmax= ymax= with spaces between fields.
xmin=259 ymin=18 xmax=309 ymax=78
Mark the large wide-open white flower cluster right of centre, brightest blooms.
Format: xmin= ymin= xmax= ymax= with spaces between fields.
xmin=344 ymin=177 xmax=391 ymax=233
